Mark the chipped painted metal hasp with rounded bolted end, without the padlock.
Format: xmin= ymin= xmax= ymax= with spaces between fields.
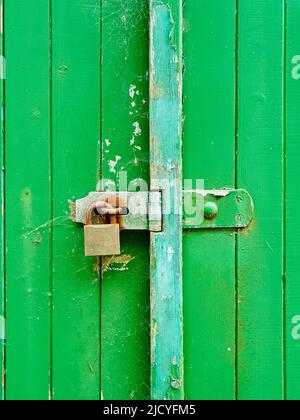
xmin=75 ymin=189 xmax=254 ymax=232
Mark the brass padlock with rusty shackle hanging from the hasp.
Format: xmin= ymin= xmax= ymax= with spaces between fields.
xmin=84 ymin=202 xmax=121 ymax=257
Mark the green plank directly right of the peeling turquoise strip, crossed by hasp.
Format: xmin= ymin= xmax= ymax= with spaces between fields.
xmin=183 ymin=0 xmax=236 ymax=400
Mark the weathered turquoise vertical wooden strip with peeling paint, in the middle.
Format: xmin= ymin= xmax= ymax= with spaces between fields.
xmin=150 ymin=0 xmax=184 ymax=400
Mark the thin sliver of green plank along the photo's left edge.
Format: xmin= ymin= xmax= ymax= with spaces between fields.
xmin=0 ymin=1 xmax=5 ymax=400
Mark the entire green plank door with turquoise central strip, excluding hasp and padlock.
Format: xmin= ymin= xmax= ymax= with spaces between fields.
xmin=0 ymin=0 xmax=300 ymax=400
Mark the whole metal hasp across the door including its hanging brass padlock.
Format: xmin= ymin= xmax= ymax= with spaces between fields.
xmin=75 ymin=189 xmax=254 ymax=256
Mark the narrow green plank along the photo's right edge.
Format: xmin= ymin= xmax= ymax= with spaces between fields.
xmin=286 ymin=0 xmax=300 ymax=400
